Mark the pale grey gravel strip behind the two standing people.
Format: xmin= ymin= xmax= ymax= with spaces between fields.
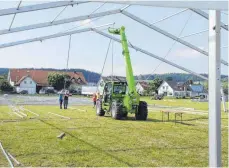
xmin=0 ymin=95 xmax=92 ymax=105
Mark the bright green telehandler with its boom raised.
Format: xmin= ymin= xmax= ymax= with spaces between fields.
xmin=96 ymin=26 xmax=148 ymax=120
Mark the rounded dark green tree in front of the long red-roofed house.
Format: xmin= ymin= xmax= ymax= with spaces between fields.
xmin=48 ymin=73 xmax=71 ymax=90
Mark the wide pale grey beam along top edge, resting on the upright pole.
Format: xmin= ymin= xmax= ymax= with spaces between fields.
xmin=93 ymin=0 xmax=228 ymax=10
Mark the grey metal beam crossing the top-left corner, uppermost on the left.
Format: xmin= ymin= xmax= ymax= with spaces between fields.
xmin=0 ymin=1 xmax=89 ymax=16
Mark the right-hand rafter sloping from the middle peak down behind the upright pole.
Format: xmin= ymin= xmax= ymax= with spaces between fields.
xmin=122 ymin=11 xmax=228 ymax=66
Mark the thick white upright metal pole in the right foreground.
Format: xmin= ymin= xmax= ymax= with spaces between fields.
xmin=208 ymin=10 xmax=221 ymax=167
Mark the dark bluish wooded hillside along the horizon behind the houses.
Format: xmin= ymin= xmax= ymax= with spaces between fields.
xmin=0 ymin=68 xmax=228 ymax=83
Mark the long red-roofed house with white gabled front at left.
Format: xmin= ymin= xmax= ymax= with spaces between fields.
xmin=8 ymin=69 xmax=87 ymax=94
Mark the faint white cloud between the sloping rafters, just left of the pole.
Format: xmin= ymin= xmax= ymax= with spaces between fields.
xmin=172 ymin=47 xmax=205 ymax=57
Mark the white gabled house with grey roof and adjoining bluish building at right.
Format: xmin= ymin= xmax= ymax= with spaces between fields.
xmin=158 ymin=81 xmax=205 ymax=97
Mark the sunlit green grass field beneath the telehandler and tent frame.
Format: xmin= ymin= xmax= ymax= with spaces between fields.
xmin=0 ymin=98 xmax=228 ymax=167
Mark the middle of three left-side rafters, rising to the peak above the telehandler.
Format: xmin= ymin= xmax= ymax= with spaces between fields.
xmin=0 ymin=9 xmax=121 ymax=35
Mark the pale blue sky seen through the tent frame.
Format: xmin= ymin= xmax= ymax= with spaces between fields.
xmin=0 ymin=1 xmax=228 ymax=76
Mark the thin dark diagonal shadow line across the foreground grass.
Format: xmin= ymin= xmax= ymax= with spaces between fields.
xmin=40 ymin=120 xmax=132 ymax=167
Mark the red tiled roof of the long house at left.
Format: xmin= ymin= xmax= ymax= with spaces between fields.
xmin=9 ymin=69 xmax=87 ymax=86
